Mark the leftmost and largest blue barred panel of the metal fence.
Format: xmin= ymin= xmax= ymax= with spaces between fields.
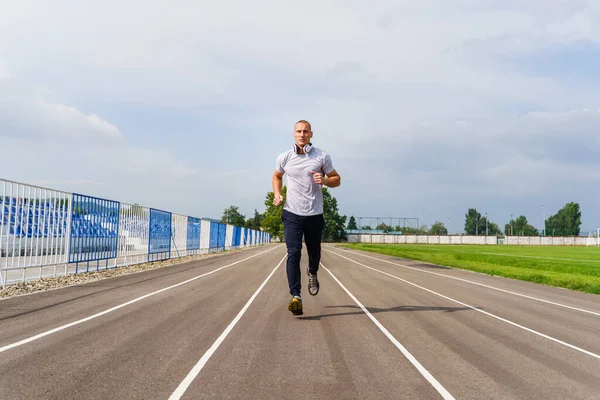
xmin=68 ymin=193 xmax=121 ymax=272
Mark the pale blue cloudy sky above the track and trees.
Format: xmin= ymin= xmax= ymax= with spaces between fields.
xmin=0 ymin=0 xmax=600 ymax=235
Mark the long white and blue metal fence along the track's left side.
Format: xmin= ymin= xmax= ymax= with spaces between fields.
xmin=0 ymin=179 xmax=271 ymax=287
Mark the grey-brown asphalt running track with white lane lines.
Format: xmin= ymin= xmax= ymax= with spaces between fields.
xmin=0 ymin=244 xmax=600 ymax=399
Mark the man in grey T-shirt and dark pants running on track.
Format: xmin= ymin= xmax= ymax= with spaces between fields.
xmin=273 ymin=120 xmax=341 ymax=315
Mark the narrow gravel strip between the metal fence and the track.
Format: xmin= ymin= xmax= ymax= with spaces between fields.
xmin=0 ymin=249 xmax=245 ymax=300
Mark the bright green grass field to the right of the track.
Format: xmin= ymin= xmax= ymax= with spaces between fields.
xmin=341 ymin=243 xmax=600 ymax=294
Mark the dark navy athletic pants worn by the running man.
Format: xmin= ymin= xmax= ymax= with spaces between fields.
xmin=281 ymin=210 xmax=325 ymax=296
